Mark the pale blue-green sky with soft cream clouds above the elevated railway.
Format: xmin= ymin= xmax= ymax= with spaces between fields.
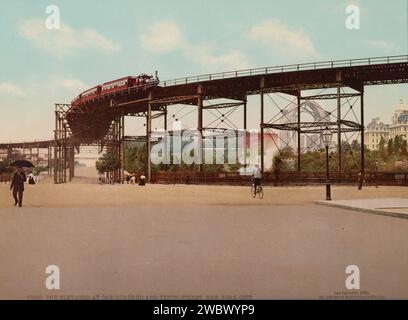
xmin=0 ymin=0 xmax=408 ymax=142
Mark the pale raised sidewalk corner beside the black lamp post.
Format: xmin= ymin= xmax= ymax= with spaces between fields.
xmin=316 ymin=198 xmax=408 ymax=219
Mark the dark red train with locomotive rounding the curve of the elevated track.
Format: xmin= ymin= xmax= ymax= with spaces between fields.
xmin=71 ymin=71 xmax=160 ymax=106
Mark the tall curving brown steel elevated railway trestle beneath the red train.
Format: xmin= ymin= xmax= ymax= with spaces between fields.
xmin=3 ymin=55 xmax=408 ymax=183
